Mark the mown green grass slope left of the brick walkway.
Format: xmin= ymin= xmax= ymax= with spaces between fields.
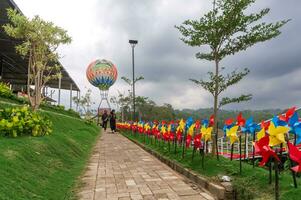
xmin=0 ymin=105 xmax=99 ymax=200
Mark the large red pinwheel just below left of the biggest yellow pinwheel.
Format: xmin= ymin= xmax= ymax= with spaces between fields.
xmin=254 ymin=135 xmax=280 ymax=166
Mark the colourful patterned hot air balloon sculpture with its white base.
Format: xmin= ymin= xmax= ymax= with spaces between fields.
xmin=87 ymin=59 xmax=117 ymax=122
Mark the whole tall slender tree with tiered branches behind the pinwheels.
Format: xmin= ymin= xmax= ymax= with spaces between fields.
xmin=176 ymin=0 xmax=289 ymax=154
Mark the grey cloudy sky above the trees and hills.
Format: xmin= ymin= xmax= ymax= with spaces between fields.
xmin=15 ymin=0 xmax=301 ymax=109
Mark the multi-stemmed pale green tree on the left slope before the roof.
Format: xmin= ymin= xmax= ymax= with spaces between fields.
xmin=3 ymin=9 xmax=71 ymax=111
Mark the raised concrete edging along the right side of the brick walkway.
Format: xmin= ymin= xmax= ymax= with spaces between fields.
xmin=121 ymin=134 xmax=233 ymax=200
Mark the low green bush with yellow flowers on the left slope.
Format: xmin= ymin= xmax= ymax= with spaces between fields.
xmin=0 ymin=106 xmax=52 ymax=137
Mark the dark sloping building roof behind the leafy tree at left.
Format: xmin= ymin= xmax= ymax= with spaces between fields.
xmin=0 ymin=0 xmax=80 ymax=91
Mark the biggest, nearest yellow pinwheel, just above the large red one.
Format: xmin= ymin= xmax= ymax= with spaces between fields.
xmin=268 ymin=122 xmax=290 ymax=146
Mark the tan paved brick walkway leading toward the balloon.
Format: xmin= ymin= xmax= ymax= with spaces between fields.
xmin=78 ymin=133 xmax=213 ymax=200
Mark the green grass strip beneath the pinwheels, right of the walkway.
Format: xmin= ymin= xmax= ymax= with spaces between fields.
xmin=123 ymin=133 xmax=301 ymax=200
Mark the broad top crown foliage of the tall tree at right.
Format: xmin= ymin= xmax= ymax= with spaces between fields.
xmin=176 ymin=0 xmax=289 ymax=61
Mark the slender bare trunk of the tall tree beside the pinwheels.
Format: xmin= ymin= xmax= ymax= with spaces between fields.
xmin=211 ymin=58 xmax=219 ymax=155
